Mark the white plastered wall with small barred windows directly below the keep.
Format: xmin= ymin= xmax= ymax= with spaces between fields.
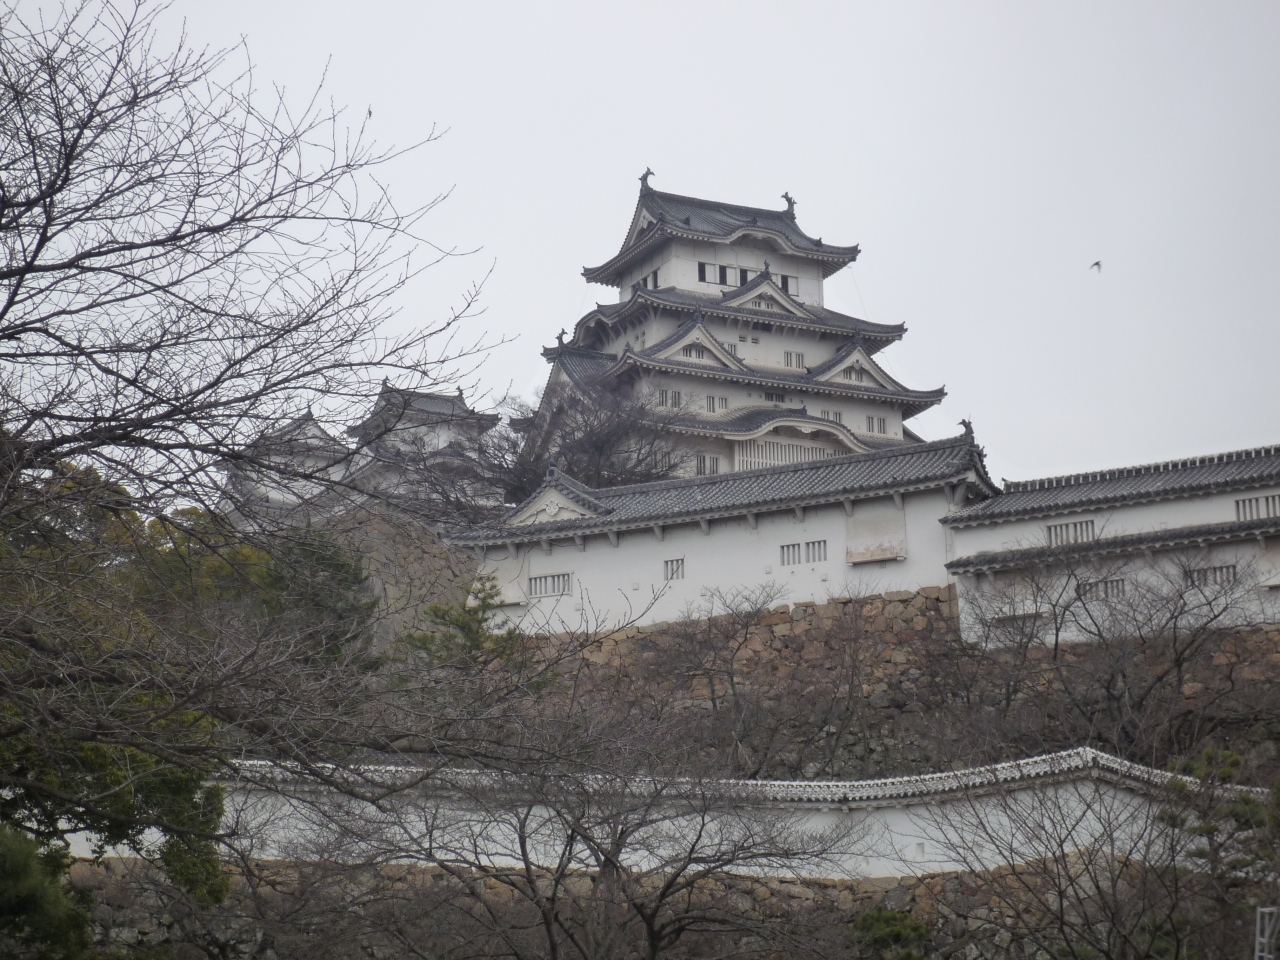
xmin=480 ymin=489 xmax=950 ymax=631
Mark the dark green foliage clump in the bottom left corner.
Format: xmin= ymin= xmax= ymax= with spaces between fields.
xmin=0 ymin=826 xmax=90 ymax=960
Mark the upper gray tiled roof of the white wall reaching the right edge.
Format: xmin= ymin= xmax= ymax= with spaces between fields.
xmin=946 ymin=447 xmax=1280 ymax=525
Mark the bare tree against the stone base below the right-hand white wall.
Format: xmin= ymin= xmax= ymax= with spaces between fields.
xmin=927 ymin=550 xmax=1280 ymax=765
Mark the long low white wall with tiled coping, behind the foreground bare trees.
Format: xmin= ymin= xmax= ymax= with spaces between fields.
xmin=215 ymin=750 xmax=1192 ymax=878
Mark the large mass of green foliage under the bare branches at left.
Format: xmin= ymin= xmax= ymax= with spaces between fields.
xmin=0 ymin=467 xmax=374 ymax=902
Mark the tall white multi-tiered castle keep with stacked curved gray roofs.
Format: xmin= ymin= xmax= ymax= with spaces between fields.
xmin=543 ymin=179 xmax=946 ymax=471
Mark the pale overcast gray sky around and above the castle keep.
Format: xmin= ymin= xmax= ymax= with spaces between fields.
xmin=170 ymin=0 xmax=1280 ymax=479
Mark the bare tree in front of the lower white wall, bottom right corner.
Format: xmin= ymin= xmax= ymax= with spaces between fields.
xmin=924 ymin=753 xmax=1277 ymax=960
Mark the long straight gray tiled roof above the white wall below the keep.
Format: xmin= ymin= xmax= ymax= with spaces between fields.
xmin=451 ymin=434 xmax=993 ymax=544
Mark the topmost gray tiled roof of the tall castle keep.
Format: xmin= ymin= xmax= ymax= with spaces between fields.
xmin=582 ymin=188 xmax=859 ymax=283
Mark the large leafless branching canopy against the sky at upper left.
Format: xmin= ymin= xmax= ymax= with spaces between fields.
xmin=0 ymin=4 xmax=481 ymax=519
